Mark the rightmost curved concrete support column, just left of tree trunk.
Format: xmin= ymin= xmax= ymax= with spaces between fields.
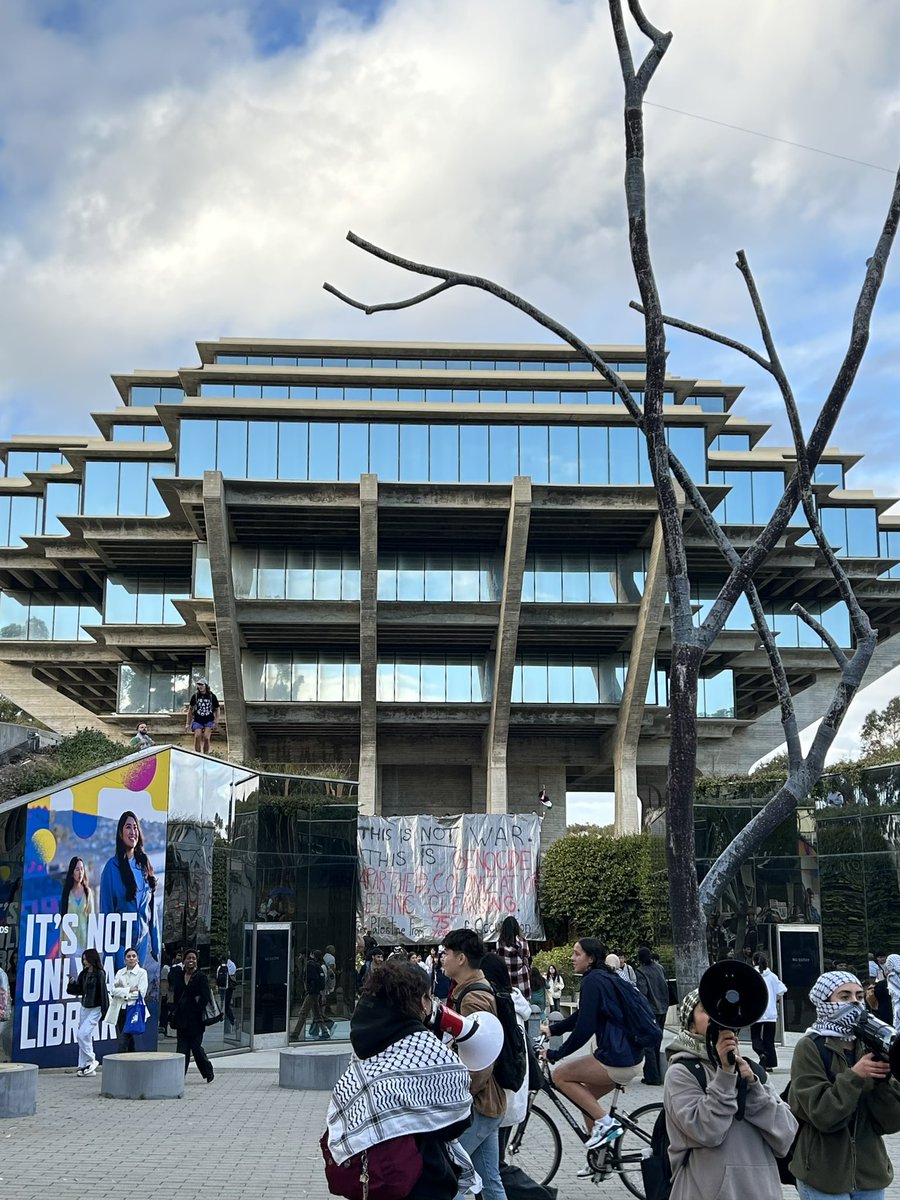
xmin=612 ymin=517 xmax=666 ymax=838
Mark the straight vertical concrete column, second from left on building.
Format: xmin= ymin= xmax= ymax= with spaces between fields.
xmin=359 ymin=475 xmax=382 ymax=816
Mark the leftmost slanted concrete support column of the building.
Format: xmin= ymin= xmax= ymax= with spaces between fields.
xmin=203 ymin=470 xmax=253 ymax=762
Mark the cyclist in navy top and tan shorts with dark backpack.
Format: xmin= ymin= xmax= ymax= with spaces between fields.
xmin=544 ymin=937 xmax=643 ymax=1178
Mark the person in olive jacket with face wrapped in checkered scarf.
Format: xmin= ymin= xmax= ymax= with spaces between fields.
xmin=790 ymin=971 xmax=900 ymax=1200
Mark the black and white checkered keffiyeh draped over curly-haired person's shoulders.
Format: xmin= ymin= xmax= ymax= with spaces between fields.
xmin=326 ymin=1030 xmax=481 ymax=1192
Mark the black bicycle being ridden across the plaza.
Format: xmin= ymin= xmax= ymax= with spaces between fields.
xmin=505 ymin=1038 xmax=662 ymax=1200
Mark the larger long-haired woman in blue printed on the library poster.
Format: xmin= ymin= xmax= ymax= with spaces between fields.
xmin=100 ymin=810 xmax=160 ymax=971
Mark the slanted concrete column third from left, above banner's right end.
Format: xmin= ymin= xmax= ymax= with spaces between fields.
xmin=485 ymin=475 xmax=532 ymax=812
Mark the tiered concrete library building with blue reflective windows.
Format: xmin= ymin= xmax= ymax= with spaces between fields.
xmin=0 ymin=338 xmax=900 ymax=834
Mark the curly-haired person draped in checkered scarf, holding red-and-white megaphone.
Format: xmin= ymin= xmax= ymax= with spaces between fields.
xmin=326 ymin=959 xmax=475 ymax=1200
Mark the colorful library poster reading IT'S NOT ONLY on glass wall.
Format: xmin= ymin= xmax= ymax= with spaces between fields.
xmin=12 ymin=751 xmax=169 ymax=1067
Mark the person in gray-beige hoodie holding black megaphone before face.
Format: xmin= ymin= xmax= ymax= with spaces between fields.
xmin=662 ymin=991 xmax=797 ymax=1200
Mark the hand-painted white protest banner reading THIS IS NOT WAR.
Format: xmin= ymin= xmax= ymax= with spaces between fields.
xmin=358 ymin=812 xmax=544 ymax=944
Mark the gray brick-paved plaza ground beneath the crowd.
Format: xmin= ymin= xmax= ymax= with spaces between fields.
xmin=0 ymin=1034 xmax=900 ymax=1200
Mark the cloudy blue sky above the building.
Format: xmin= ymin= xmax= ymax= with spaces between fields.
xmin=0 ymin=0 xmax=900 ymax=782
